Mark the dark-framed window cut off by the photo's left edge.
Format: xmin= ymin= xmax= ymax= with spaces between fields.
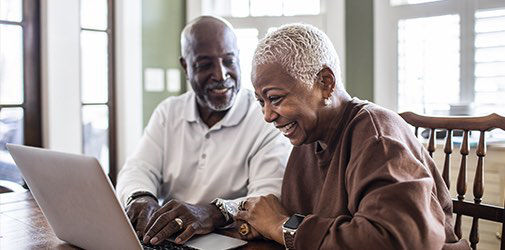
xmin=0 ymin=0 xmax=42 ymax=184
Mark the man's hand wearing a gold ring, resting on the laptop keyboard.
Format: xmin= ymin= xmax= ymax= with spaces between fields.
xmin=143 ymin=200 xmax=225 ymax=245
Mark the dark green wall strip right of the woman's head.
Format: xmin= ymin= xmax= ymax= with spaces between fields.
xmin=345 ymin=0 xmax=374 ymax=101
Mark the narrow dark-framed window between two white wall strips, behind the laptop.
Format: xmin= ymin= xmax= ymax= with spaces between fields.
xmin=80 ymin=0 xmax=116 ymax=182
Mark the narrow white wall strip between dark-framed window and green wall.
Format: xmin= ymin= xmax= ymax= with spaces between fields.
xmin=116 ymin=0 xmax=142 ymax=168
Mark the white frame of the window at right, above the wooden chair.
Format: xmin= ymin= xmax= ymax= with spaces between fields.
xmin=374 ymin=0 xmax=505 ymax=111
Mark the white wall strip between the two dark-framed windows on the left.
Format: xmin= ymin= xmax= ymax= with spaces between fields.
xmin=41 ymin=0 xmax=82 ymax=153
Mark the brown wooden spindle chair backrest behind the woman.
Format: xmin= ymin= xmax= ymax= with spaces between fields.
xmin=400 ymin=112 xmax=505 ymax=250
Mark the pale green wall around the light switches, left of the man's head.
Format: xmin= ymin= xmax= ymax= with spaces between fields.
xmin=142 ymin=0 xmax=186 ymax=126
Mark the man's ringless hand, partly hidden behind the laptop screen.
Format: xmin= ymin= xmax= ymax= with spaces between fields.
xmin=126 ymin=196 xmax=160 ymax=237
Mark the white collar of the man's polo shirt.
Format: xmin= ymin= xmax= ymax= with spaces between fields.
xmin=184 ymin=89 xmax=250 ymax=129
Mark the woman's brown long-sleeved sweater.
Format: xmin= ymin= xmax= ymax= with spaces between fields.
xmin=281 ymin=98 xmax=469 ymax=250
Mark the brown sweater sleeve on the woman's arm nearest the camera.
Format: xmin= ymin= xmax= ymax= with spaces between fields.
xmin=295 ymin=137 xmax=445 ymax=249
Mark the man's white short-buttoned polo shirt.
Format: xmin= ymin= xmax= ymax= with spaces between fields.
xmin=117 ymin=89 xmax=291 ymax=205
